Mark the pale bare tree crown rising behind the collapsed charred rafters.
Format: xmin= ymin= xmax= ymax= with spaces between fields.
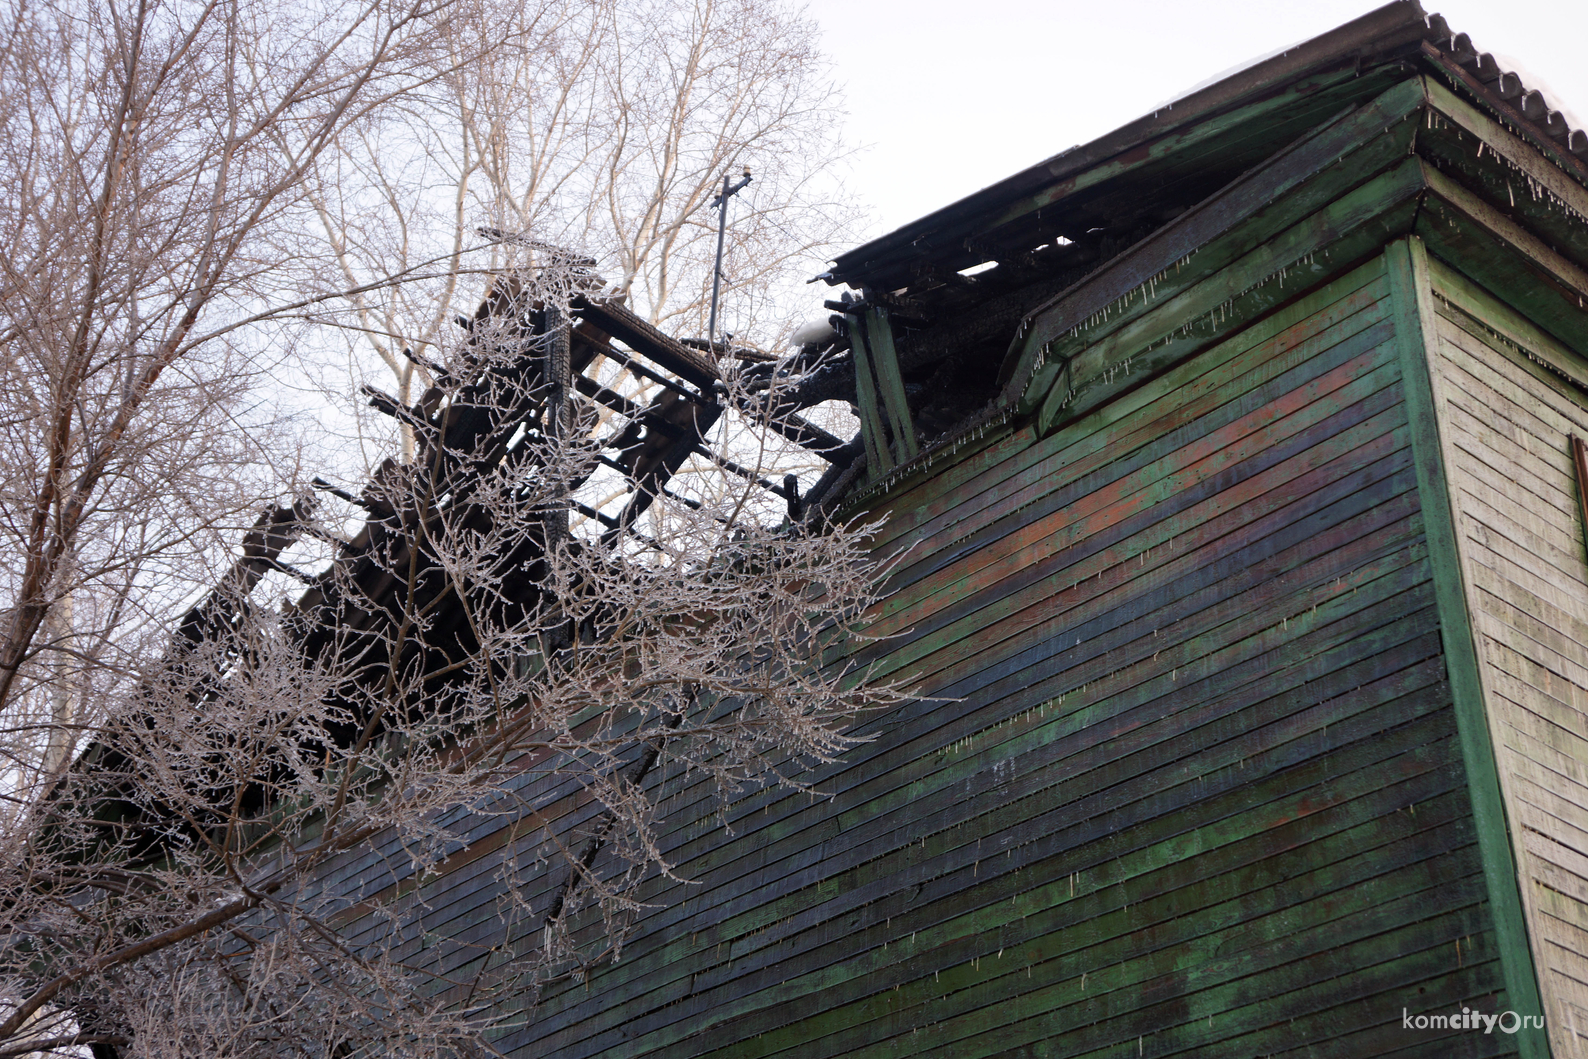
xmin=304 ymin=0 xmax=854 ymax=435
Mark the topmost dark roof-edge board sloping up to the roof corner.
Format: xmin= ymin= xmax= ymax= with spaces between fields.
xmin=829 ymin=0 xmax=1431 ymax=289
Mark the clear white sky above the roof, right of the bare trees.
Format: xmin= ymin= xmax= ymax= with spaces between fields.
xmin=807 ymin=0 xmax=1588 ymax=246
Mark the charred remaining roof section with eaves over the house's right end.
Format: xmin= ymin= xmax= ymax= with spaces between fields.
xmin=807 ymin=0 xmax=1588 ymax=506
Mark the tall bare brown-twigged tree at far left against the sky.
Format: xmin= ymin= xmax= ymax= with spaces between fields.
xmin=0 ymin=0 xmax=501 ymax=791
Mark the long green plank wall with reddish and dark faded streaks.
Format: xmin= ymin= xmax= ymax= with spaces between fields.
xmin=434 ymin=262 xmax=1517 ymax=1057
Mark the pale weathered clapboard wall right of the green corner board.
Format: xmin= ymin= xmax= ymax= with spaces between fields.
xmin=1432 ymin=262 xmax=1588 ymax=1056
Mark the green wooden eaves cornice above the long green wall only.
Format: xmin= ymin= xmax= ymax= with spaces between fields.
xmin=1000 ymin=79 xmax=1426 ymax=427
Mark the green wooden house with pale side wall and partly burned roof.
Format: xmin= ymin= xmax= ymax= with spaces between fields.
xmin=273 ymin=0 xmax=1588 ymax=1059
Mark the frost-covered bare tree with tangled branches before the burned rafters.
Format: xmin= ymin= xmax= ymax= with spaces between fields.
xmin=0 ymin=254 xmax=900 ymax=1056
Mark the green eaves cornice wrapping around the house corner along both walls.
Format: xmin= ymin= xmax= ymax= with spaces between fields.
xmin=1004 ymin=78 xmax=1588 ymax=444
